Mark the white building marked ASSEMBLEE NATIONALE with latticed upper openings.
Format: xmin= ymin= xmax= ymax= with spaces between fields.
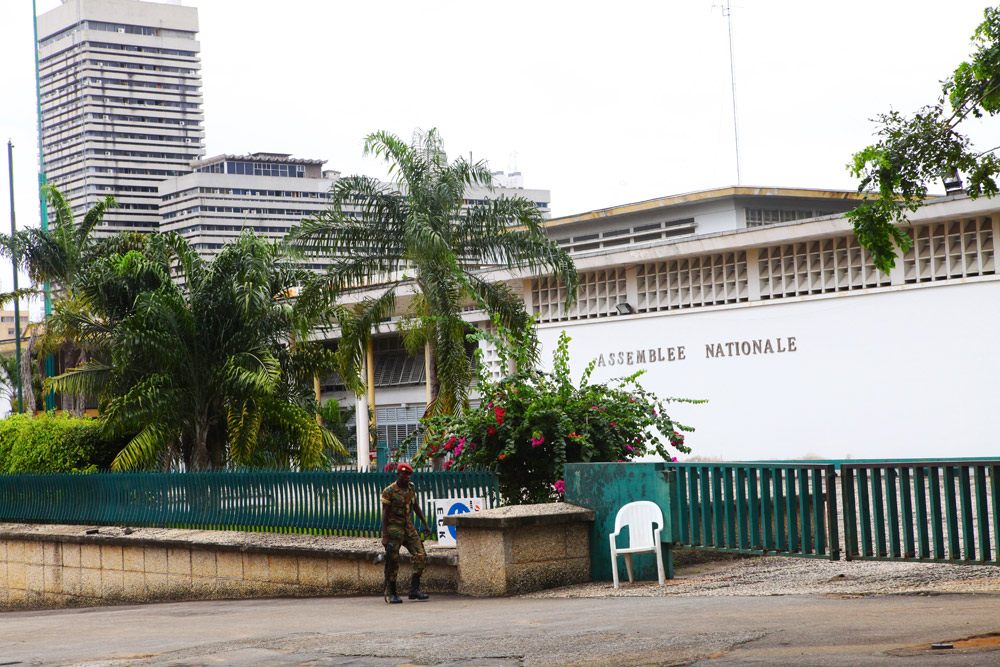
xmin=337 ymin=188 xmax=1000 ymax=460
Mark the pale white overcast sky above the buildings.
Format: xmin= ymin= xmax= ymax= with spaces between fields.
xmin=0 ymin=0 xmax=1000 ymax=316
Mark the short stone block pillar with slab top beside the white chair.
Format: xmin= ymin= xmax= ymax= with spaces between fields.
xmin=443 ymin=503 xmax=594 ymax=596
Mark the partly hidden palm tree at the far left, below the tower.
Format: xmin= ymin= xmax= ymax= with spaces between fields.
xmin=0 ymin=185 xmax=118 ymax=416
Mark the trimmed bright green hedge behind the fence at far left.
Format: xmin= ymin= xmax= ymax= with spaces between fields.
xmin=0 ymin=413 xmax=125 ymax=473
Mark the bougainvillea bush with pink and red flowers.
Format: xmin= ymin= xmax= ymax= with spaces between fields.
xmin=417 ymin=332 xmax=703 ymax=503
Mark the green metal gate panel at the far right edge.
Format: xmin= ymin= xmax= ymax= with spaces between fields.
xmin=840 ymin=460 xmax=1000 ymax=565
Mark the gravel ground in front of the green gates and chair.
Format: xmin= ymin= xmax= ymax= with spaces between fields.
xmin=523 ymin=556 xmax=1000 ymax=598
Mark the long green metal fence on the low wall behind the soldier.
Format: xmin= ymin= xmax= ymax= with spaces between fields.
xmin=0 ymin=471 xmax=499 ymax=536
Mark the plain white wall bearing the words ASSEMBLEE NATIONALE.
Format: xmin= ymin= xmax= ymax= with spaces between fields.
xmin=538 ymin=281 xmax=1000 ymax=460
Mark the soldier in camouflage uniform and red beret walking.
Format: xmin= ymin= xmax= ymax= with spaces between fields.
xmin=382 ymin=463 xmax=430 ymax=604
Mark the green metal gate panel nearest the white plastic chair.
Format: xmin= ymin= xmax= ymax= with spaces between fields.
xmin=665 ymin=463 xmax=840 ymax=560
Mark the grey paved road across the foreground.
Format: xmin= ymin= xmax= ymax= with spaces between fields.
xmin=0 ymin=594 xmax=1000 ymax=667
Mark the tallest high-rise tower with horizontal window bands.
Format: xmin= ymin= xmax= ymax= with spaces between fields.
xmin=38 ymin=0 xmax=205 ymax=235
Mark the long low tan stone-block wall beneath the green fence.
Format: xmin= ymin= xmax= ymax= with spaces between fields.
xmin=0 ymin=524 xmax=458 ymax=610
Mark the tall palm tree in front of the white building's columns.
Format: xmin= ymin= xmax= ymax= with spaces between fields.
xmin=287 ymin=130 xmax=577 ymax=414
